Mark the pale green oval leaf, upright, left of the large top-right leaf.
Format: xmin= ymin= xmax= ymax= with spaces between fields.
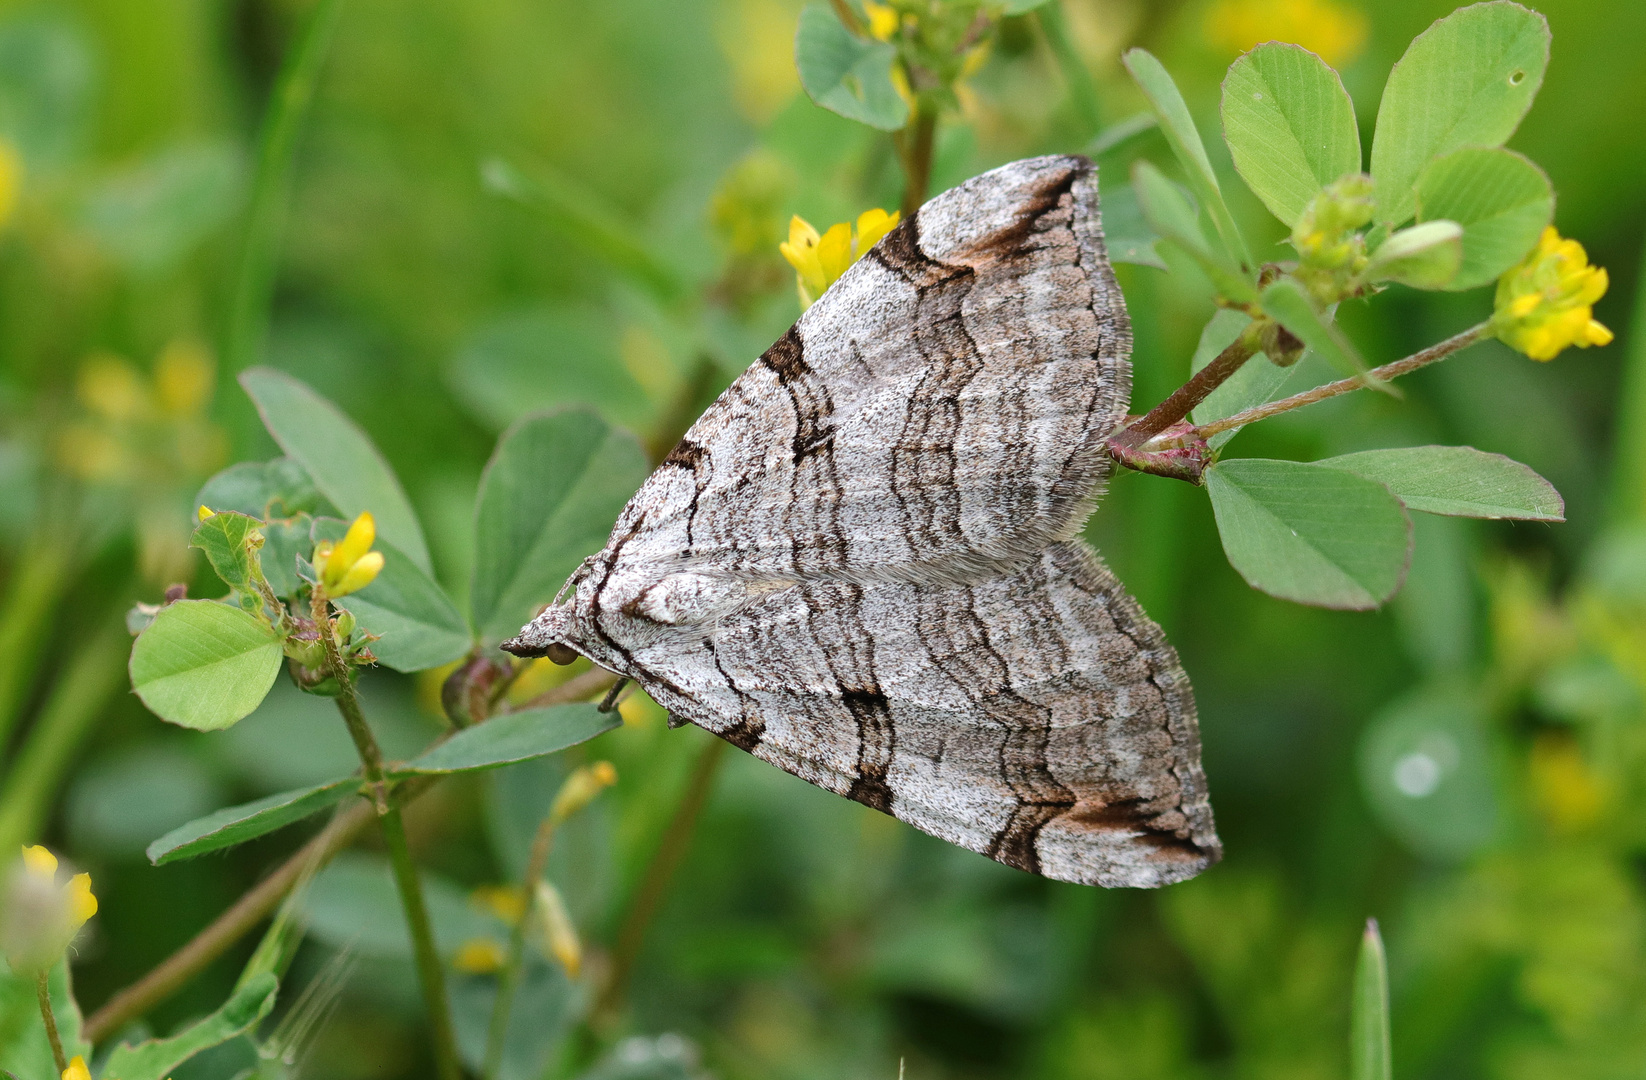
xmin=1223 ymin=41 xmax=1360 ymax=226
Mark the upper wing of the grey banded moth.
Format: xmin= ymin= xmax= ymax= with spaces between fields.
xmin=619 ymin=156 xmax=1131 ymax=576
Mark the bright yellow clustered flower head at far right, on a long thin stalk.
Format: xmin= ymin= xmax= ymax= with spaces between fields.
xmin=1491 ymin=226 xmax=1611 ymax=361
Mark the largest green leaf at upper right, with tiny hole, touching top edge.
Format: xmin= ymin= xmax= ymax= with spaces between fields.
xmin=1371 ymin=0 xmax=1549 ymax=226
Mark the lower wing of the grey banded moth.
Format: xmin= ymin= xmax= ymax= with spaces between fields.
xmin=635 ymin=540 xmax=1221 ymax=886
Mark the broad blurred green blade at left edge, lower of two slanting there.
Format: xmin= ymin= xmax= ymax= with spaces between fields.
xmin=0 ymin=617 xmax=132 ymax=851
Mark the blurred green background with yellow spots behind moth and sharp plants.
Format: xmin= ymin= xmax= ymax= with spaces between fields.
xmin=0 ymin=0 xmax=1646 ymax=1080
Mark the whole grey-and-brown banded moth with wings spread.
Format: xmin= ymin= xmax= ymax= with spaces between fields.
xmin=504 ymin=156 xmax=1221 ymax=886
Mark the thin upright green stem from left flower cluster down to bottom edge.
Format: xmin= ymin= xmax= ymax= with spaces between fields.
xmin=309 ymin=586 xmax=463 ymax=1080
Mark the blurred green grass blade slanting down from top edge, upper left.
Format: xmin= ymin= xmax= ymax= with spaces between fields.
xmin=224 ymin=0 xmax=339 ymax=374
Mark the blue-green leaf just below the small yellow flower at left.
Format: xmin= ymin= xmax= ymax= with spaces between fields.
xmin=314 ymin=517 xmax=472 ymax=673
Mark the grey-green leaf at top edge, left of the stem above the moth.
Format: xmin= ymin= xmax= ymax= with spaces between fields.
xmin=795 ymin=3 xmax=909 ymax=132
